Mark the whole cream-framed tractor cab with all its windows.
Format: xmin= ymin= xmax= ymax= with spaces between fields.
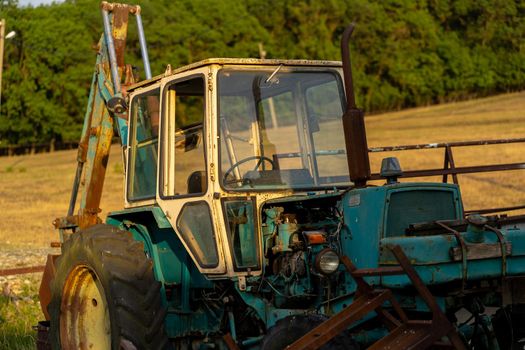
xmin=125 ymin=59 xmax=351 ymax=276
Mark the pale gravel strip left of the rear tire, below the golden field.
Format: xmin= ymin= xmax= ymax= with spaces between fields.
xmin=0 ymin=248 xmax=60 ymax=299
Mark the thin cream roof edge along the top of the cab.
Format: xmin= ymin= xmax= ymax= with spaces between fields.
xmin=127 ymin=58 xmax=342 ymax=92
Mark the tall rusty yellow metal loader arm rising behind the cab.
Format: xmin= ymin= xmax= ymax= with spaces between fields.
xmin=59 ymin=2 xmax=144 ymax=232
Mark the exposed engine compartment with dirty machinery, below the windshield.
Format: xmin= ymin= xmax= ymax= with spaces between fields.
xmin=258 ymin=196 xmax=344 ymax=308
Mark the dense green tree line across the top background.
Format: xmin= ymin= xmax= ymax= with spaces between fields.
xmin=0 ymin=0 xmax=525 ymax=146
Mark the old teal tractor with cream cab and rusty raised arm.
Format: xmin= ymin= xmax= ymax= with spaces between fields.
xmin=40 ymin=2 xmax=525 ymax=350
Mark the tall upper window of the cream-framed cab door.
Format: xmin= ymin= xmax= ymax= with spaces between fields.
xmin=163 ymin=77 xmax=207 ymax=196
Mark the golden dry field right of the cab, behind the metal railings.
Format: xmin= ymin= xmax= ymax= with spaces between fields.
xmin=366 ymin=92 xmax=525 ymax=210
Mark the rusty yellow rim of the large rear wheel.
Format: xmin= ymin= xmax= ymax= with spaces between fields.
xmin=60 ymin=266 xmax=111 ymax=350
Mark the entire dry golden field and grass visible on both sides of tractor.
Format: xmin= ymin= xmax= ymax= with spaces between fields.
xmin=0 ymin=92 xmax=525 ymax=349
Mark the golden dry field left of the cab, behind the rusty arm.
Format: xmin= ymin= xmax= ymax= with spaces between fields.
xmin=0 ymin=145 xmax=124 ymax=248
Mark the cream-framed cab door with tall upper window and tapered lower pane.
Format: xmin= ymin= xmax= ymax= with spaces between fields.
xmin=157 ymin=67 xmax=226 ymax=274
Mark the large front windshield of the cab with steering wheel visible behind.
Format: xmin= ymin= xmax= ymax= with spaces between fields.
xmin=218 ymin=66 xmax=350 ymax=190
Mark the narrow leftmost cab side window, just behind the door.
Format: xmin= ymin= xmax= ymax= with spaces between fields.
xmin=128 ymin=89 xmax=160 ymax=201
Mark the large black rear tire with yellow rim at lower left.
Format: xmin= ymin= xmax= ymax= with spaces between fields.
xmin=48 ymin=224 xmax=168 ymax=350
